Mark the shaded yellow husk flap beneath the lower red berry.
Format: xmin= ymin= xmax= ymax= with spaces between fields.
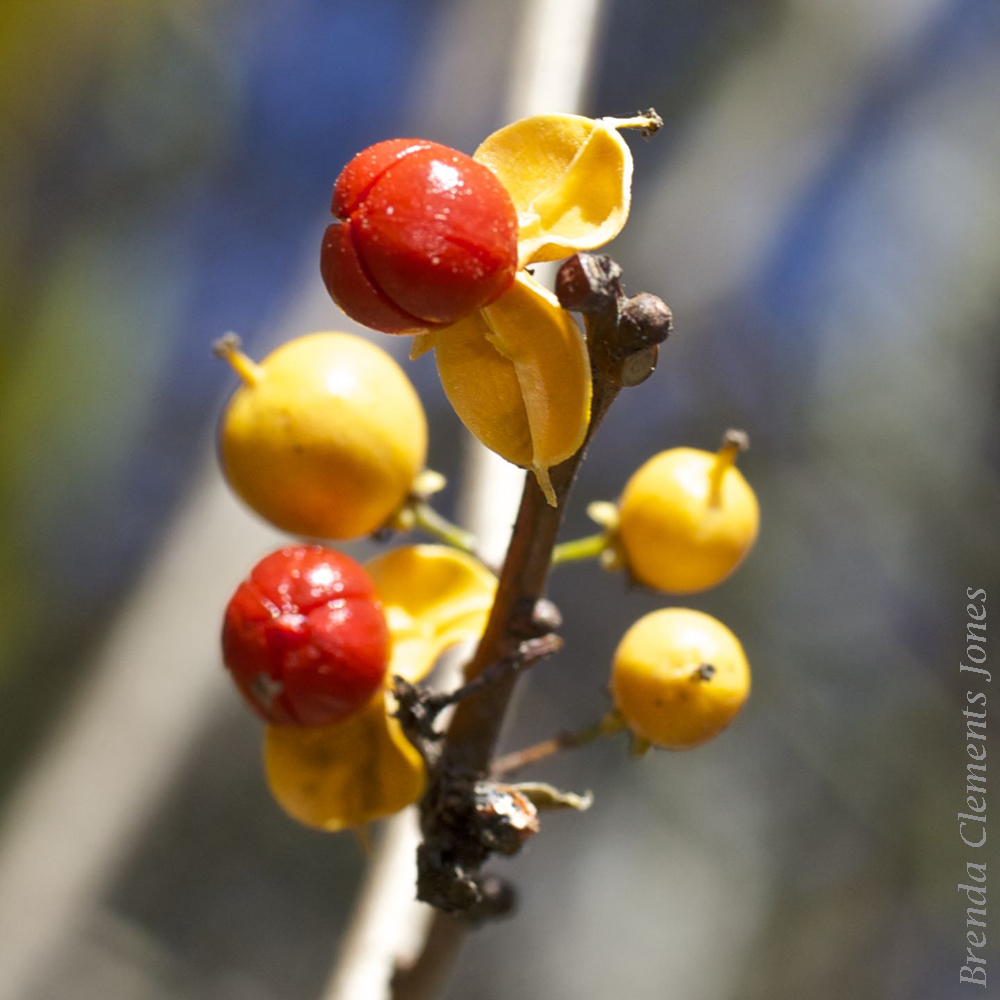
xmin=264 ymin=691 xmax=426 ymax=832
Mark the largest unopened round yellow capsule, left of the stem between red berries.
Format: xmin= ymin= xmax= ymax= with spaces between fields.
xmin=219 ymin=333 xmax=427 ymax=538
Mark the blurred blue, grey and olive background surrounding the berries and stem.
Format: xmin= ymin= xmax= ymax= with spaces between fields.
xmin=0 ymin=0 xmax=1000 ymax=1000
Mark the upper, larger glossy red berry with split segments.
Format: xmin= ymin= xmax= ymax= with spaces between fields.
xmin=320 ymin=139 xmax=518 ymax=333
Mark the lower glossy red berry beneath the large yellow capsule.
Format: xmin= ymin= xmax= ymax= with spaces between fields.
xmin=222 ymin=545 xmax=390 ymax=726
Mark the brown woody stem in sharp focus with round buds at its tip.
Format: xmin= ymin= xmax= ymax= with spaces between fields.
xmin=393 ymin=254 xmax=671 ymax=1000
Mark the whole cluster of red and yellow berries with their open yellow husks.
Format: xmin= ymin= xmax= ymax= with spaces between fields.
xmin=217 ymin=115 xmax=758 ymax=830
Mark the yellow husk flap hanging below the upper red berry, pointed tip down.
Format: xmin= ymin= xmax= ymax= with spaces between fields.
xmin=434 ymin=274 xmax=592 ymax=506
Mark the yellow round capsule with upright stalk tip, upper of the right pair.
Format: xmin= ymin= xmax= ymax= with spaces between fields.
xmin=618 ymin=432 xmax=760 ymax=594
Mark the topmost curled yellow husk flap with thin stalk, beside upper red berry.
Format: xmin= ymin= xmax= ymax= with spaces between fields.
xmin=474 ymin=114 xmax=651 ymax=267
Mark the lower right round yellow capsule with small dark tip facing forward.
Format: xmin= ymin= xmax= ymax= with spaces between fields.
xmin=611 ymin=608 xmax=750 ymax=750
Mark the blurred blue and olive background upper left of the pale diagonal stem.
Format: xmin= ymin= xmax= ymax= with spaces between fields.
xmin=0 ymin=0 xmax=431 ymax=787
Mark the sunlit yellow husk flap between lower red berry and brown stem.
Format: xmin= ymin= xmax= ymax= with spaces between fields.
xmin=365 ymin=545 xmax=497 ymax=682
